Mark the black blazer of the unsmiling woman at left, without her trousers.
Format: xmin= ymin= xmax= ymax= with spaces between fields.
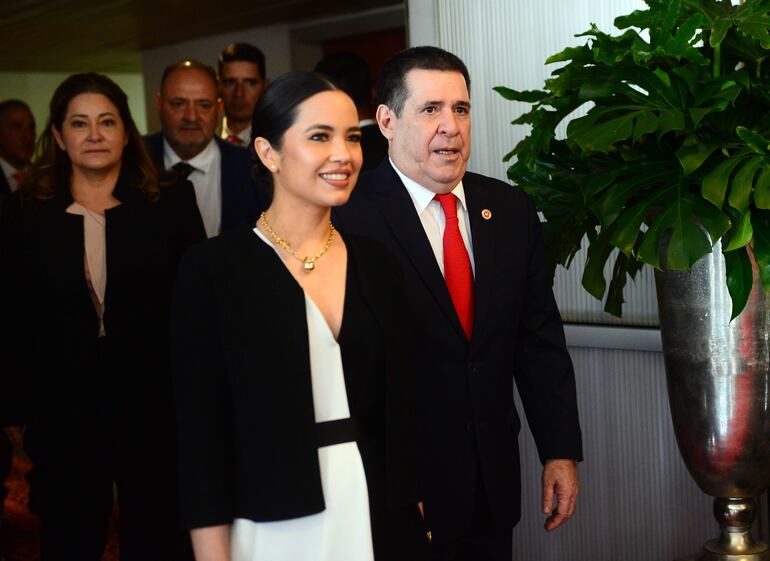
xmin=0 ymin=173 xmax=205 ymax=433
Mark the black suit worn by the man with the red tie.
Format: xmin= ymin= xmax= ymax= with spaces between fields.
xmin=334 ymin=160 xmax=582 ymax=532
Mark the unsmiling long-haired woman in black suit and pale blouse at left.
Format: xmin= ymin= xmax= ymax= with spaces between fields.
xmin=0 ymin=73 xmax=205 ymax=561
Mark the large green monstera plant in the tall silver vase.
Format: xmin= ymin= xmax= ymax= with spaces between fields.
xmin=495 ymin=0 xmax=770 ymax=317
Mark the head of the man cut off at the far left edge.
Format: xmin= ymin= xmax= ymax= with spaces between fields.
xmin=0 ymin=99 xmax=35 ymax=199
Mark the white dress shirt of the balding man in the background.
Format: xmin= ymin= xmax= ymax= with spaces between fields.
xmin=163 ymin=138 xmax=222 ymax=238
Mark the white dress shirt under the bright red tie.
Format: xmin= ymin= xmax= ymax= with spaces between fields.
xmin=389 ymin=158 xmax=476 ymax=276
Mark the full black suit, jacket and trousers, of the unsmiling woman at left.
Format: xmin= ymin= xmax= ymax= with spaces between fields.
xmin=0 ymin=174 xmax=205 ymax=561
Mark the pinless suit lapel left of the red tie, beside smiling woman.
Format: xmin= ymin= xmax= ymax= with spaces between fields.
xmin=374 ymin=160 xmax=465 ymax=339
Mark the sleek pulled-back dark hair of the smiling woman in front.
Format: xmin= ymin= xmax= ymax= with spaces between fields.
xmin=249 ymin=72 xmax=340 ymax=186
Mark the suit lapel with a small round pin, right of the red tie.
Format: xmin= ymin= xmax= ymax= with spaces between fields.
xmin=463 ymin=175 xmax=495 ymax=342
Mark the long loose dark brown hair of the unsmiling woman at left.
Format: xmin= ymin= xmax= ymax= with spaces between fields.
xmin=21 ymin=72 xmax=159 ymax=200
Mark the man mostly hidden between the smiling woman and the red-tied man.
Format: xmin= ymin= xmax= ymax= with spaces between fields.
xmin=315 ymin=53 xmax=388 ymax=172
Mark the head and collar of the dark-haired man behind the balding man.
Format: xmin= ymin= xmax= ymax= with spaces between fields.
xmin=217 ymin=43 xmax=268 ymax=145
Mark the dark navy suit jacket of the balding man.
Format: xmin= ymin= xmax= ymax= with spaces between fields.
xmin=144 ymin=132 xmax=270 ymax=232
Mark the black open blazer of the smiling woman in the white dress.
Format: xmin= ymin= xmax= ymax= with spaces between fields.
xmin=172 ymin=228 xmax=417 ymax=528
